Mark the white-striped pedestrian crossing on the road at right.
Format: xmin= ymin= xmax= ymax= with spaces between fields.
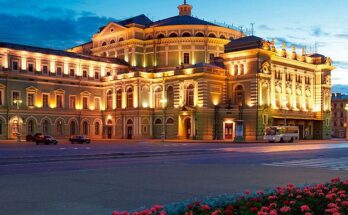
xmin=263 ymin=157 xmax=348 ymax=170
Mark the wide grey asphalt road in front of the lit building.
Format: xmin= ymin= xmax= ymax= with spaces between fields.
xmin=0 ymin=142 xmax=348 ymax=215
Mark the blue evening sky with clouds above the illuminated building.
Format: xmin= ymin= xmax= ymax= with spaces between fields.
xmin=0 ymin=0 xmax=348 ymax=90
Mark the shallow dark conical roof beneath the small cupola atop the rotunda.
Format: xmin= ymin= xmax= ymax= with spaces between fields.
xmin=151 ymin=16 xmax=218 ymax=27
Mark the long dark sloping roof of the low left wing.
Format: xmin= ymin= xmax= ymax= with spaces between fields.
xmin=0 ymin=42 xmax=129 ymax=66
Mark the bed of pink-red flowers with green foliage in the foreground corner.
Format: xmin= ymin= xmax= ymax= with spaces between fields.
xmin=112 ymin=178 xmax=348 ymax=215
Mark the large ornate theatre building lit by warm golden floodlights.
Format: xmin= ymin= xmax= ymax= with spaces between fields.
xmin=0 ymin=3 xmax=334 ymax=141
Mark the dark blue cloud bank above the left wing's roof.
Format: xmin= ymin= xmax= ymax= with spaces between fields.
xmin=0 ymin=12 xmax=115 ymax=49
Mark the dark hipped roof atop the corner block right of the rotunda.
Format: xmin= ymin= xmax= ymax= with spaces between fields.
xmin=225 ymin=36 xmax=263 ymax=53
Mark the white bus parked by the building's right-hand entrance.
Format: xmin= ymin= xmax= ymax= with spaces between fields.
xmin=264 ymin=126 xmax=300 ymax=143
